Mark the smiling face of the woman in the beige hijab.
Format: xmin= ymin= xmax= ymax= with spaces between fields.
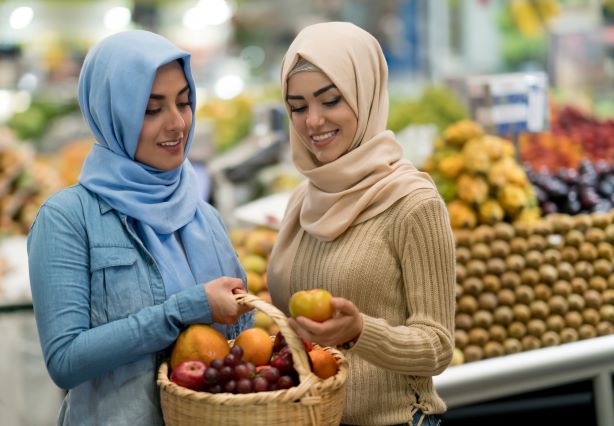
xmin=286 ymin=71 xmax=358 ymax=164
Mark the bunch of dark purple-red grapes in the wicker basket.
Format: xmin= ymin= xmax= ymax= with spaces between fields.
xmin=203 ymin=345 xmax=295 ymax=394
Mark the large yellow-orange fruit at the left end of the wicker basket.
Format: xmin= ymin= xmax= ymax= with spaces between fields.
xmin=171 ymin=324 xmax=230 ymax=369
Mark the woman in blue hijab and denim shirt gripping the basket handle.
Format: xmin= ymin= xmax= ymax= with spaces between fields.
xmin=28 ymin=31 xmax=252 ymax=426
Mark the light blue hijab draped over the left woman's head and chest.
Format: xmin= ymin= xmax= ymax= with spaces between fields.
xmin=78 ymin=30 xmax=243 ymax=296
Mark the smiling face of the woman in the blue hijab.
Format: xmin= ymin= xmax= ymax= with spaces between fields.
xmin=134 ymin=61 xmax=192 ymax=170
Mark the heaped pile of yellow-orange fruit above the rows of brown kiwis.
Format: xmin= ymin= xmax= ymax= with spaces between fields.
xmin=423 ymin=120 xmax=541 ymax=228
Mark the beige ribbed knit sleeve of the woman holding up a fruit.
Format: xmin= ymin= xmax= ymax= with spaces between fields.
xmin=352 ymin=191 xmax=455 ymax=376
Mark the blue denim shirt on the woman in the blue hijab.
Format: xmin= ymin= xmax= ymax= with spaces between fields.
xmin=28 ymin=185 xmax=253 ymax=426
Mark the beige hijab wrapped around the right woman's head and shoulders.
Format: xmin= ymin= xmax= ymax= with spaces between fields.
xmin=267 ymin=22 xmax=435 ymax=312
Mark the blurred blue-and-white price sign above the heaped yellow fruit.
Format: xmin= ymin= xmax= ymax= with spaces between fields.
xmin=463 ymin=72 xmax=548 ymax=135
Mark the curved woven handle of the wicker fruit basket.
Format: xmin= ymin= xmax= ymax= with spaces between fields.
xmin=234 ymin=293 xmax=318 ymax=383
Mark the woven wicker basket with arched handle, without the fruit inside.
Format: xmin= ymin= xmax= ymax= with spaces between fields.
xmin=158 ymin=294 xmax=348 ymax=426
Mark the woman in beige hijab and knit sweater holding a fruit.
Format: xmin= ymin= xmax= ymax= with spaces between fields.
xmin=268 ymin=22 xmax=455 ymax=425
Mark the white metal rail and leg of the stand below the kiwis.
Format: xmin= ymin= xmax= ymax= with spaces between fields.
xmin=434 ymin=336 xmax=614 ymax=426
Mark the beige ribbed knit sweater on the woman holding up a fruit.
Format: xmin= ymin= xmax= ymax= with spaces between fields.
xmin=291 ymin=190 xmax=455 ymax=425
